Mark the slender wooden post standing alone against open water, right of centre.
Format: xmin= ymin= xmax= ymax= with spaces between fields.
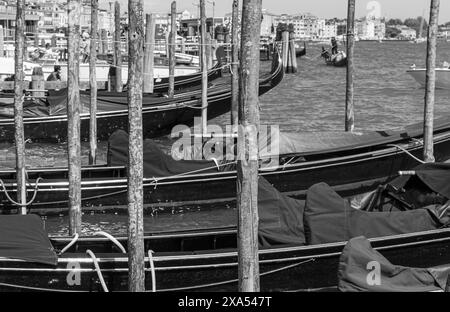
xmin=345 ymin=0 xmax=355 ymax=132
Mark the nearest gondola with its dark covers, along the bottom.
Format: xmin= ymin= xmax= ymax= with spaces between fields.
xmin=0 ymin=164 xmax=450 ymax=292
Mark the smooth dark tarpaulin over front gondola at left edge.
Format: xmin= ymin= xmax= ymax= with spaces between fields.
xmin=0 ymin=215 xmax=58 ymax=266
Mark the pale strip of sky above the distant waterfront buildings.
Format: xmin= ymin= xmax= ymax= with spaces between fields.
xmin=100 ymin=0 xmax=450 ymax=24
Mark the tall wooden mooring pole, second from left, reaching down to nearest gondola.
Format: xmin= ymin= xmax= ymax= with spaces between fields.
xmin=67 ymin=0 xmax=81 ymax=235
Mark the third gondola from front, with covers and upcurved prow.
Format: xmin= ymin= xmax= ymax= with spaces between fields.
xmin=0 ymin=49 xmax=284 ymax=142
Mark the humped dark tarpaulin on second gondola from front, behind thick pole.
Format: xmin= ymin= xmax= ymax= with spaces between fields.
xmin=108 ymin=130 xmax=218 ymax=178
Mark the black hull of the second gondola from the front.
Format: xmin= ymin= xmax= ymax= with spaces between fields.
xmin=0 ymin=127 xmax=450 ymax=215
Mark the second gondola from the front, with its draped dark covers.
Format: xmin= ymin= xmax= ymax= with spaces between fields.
xmin=0 ymin=117 xmax=450 ymax=215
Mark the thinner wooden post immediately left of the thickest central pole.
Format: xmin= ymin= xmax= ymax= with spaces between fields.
xmin=231 ymin=0 xmax=239 ymax=130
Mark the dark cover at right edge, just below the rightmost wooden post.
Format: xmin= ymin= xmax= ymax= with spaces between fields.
xmin=390 ymin=163 xmax=450 ymax=199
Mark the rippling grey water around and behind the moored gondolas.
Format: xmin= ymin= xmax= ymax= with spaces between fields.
xmin=0 ymin=42 xmax=450 ymax=235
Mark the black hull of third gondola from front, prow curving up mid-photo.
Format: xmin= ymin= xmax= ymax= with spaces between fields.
xmin=0 ymin=53 xmax=284 ymax=142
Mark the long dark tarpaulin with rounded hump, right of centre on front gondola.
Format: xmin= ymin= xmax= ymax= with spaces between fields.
xmin=304 ymin=183 xmax=446 ymax=245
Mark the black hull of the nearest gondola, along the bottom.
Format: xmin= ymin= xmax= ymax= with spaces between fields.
xmin=0 ymin=229 xmax=450 ymax=292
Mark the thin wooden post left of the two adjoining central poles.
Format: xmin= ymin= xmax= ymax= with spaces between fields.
xmin=200 ymin=0 xmax=208 ymax=135
